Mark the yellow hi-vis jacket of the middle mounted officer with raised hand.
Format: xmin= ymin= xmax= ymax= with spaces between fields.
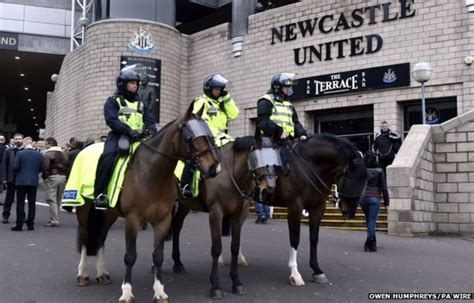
xmin=193 ymin=94 xmax=239 ymax=147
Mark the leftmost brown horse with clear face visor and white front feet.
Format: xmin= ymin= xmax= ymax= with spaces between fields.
xmin=77 ymin=104 xmax=220 ymax=302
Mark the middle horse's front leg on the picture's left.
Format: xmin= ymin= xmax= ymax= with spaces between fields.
xmin=209 ymin=207 xmax=223 ymax=300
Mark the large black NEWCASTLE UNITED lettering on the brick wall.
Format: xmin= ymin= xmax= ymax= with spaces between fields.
xmin=270 ymin=0 xmax=416 ymax=65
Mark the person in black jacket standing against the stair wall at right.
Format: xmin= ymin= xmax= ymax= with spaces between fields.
xmin=372 ymin=121 xmax=402 ymax=175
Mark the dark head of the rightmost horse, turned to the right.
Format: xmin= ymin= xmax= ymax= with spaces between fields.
xmin=337 ymin=153 xmax=367 ymax=219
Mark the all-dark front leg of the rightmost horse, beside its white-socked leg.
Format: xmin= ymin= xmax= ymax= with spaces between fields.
xmin=309 ymin=202 xmax=329 ymax=284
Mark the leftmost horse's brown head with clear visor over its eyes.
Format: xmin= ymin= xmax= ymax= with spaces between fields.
xmin=179 ymin=102 xmax=221 ymax=178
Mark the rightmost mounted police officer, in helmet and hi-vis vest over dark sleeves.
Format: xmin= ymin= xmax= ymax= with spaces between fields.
xmin=257 ymin=73 xmax=308 ymax=142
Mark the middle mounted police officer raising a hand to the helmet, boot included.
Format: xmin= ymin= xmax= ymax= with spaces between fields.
xmin=180 ymin=74 xmax=239 ymax=198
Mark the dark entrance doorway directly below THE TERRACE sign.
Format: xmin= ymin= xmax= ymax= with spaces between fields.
xmin=314 ymin=105 xmax=374 ymax=153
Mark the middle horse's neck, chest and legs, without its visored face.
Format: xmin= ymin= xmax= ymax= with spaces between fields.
xmin=168 ymin=137 xmax=255 ymax=299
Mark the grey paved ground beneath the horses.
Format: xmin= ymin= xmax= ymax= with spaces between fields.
xmin=0 ymin=189 xmax=474 ymax=303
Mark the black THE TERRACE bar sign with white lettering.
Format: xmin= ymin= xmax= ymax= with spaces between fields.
xmin=291 ymin=63 xmax=410 ymax=100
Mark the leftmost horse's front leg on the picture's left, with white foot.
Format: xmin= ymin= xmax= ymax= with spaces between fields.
xmin=119 ymin=215 xmax=140 ymax=303
